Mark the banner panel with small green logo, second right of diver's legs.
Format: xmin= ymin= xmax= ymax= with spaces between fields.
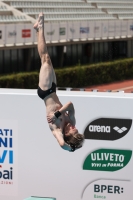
xmin=59 ymin=22 xmax=68 ymax=40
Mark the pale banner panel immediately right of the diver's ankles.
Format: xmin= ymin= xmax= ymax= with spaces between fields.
xmin=44 ymin=23 xmax=51 ymax=42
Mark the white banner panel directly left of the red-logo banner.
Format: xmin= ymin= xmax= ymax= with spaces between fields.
xmin=16 ymin=24 xmax=25 ymax=44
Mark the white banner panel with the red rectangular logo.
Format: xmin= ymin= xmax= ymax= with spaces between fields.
xmin=21 ymin=24 xmax=34 ymax=43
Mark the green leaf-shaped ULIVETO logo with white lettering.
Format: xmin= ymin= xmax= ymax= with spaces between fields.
xmin=83 ymin=149 xmax=132 ymax=172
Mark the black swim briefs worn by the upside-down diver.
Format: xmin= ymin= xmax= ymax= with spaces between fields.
xmin=37 ymin=83 xmax=56 ymax=99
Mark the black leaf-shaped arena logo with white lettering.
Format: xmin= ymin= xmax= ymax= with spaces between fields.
xmin=84 ymin=118 xmax=132 ymax=140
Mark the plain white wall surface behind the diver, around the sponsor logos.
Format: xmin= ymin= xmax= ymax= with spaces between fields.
xmin=0 ymin=89 xmax=133 ymax=200
